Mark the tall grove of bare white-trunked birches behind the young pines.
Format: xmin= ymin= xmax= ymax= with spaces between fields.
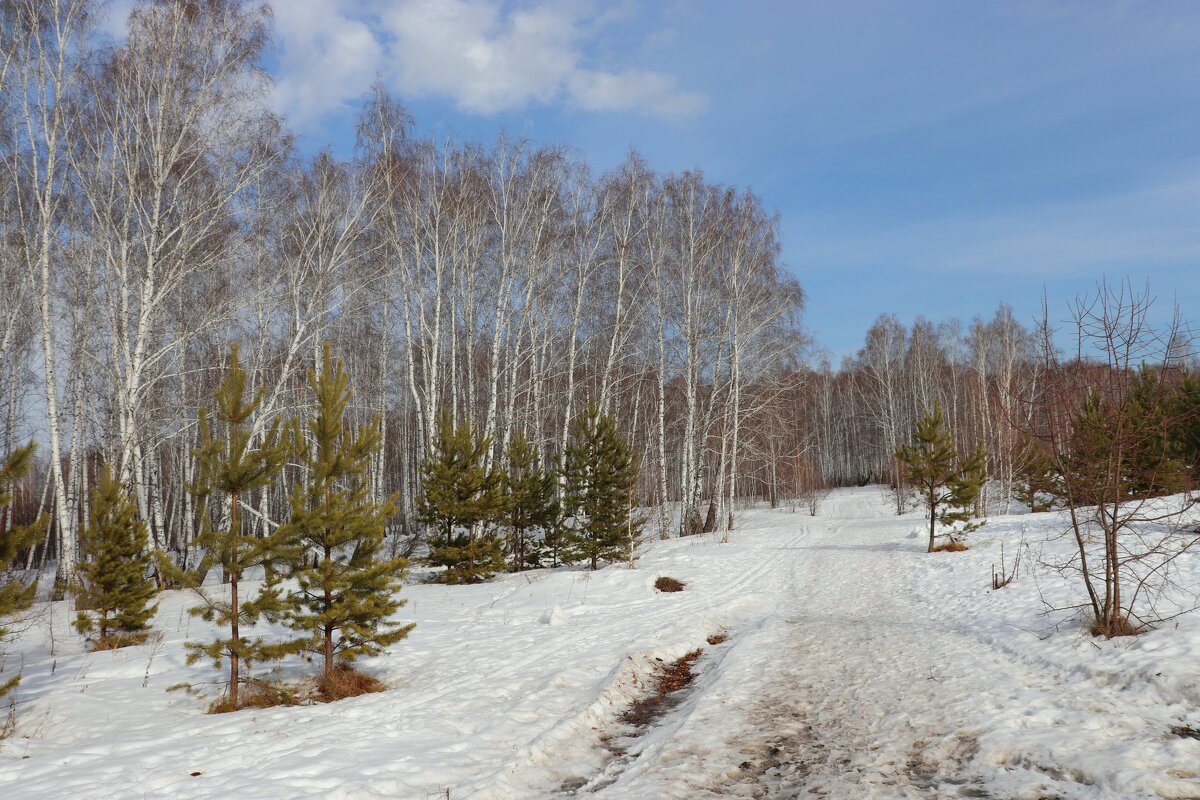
xmin=0 ymin=0 xmax=1190 ymax=587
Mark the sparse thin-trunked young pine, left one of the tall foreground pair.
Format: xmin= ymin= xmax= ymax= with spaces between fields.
xmin=179 ymin=345 xmax=300 ymax=709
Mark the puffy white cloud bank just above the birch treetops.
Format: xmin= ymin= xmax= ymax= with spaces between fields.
xmin=276 ymin=0 xmax=707 ymax=126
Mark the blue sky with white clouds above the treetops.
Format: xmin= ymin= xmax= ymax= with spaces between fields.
xmin=138 ymin=0 xmax=1200 ymax=356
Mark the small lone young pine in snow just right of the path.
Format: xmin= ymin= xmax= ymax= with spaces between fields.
xmin=895 ymin=404 xmax=988 ymax=553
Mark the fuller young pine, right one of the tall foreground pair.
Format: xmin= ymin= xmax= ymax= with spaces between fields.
xmin=280 ymin=345 xmax=413 ymax=687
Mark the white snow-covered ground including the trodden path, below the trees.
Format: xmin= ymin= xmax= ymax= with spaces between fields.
xmin=0 ymin=487 xmax=1200 ymax=800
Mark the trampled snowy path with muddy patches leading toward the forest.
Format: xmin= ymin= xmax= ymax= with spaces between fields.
xmin=601 ymin=493 xmax=1200 ymax=799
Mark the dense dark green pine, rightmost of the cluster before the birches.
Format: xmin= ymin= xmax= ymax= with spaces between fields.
xmin=563 ymin=401 xmax=642 ymax=570
